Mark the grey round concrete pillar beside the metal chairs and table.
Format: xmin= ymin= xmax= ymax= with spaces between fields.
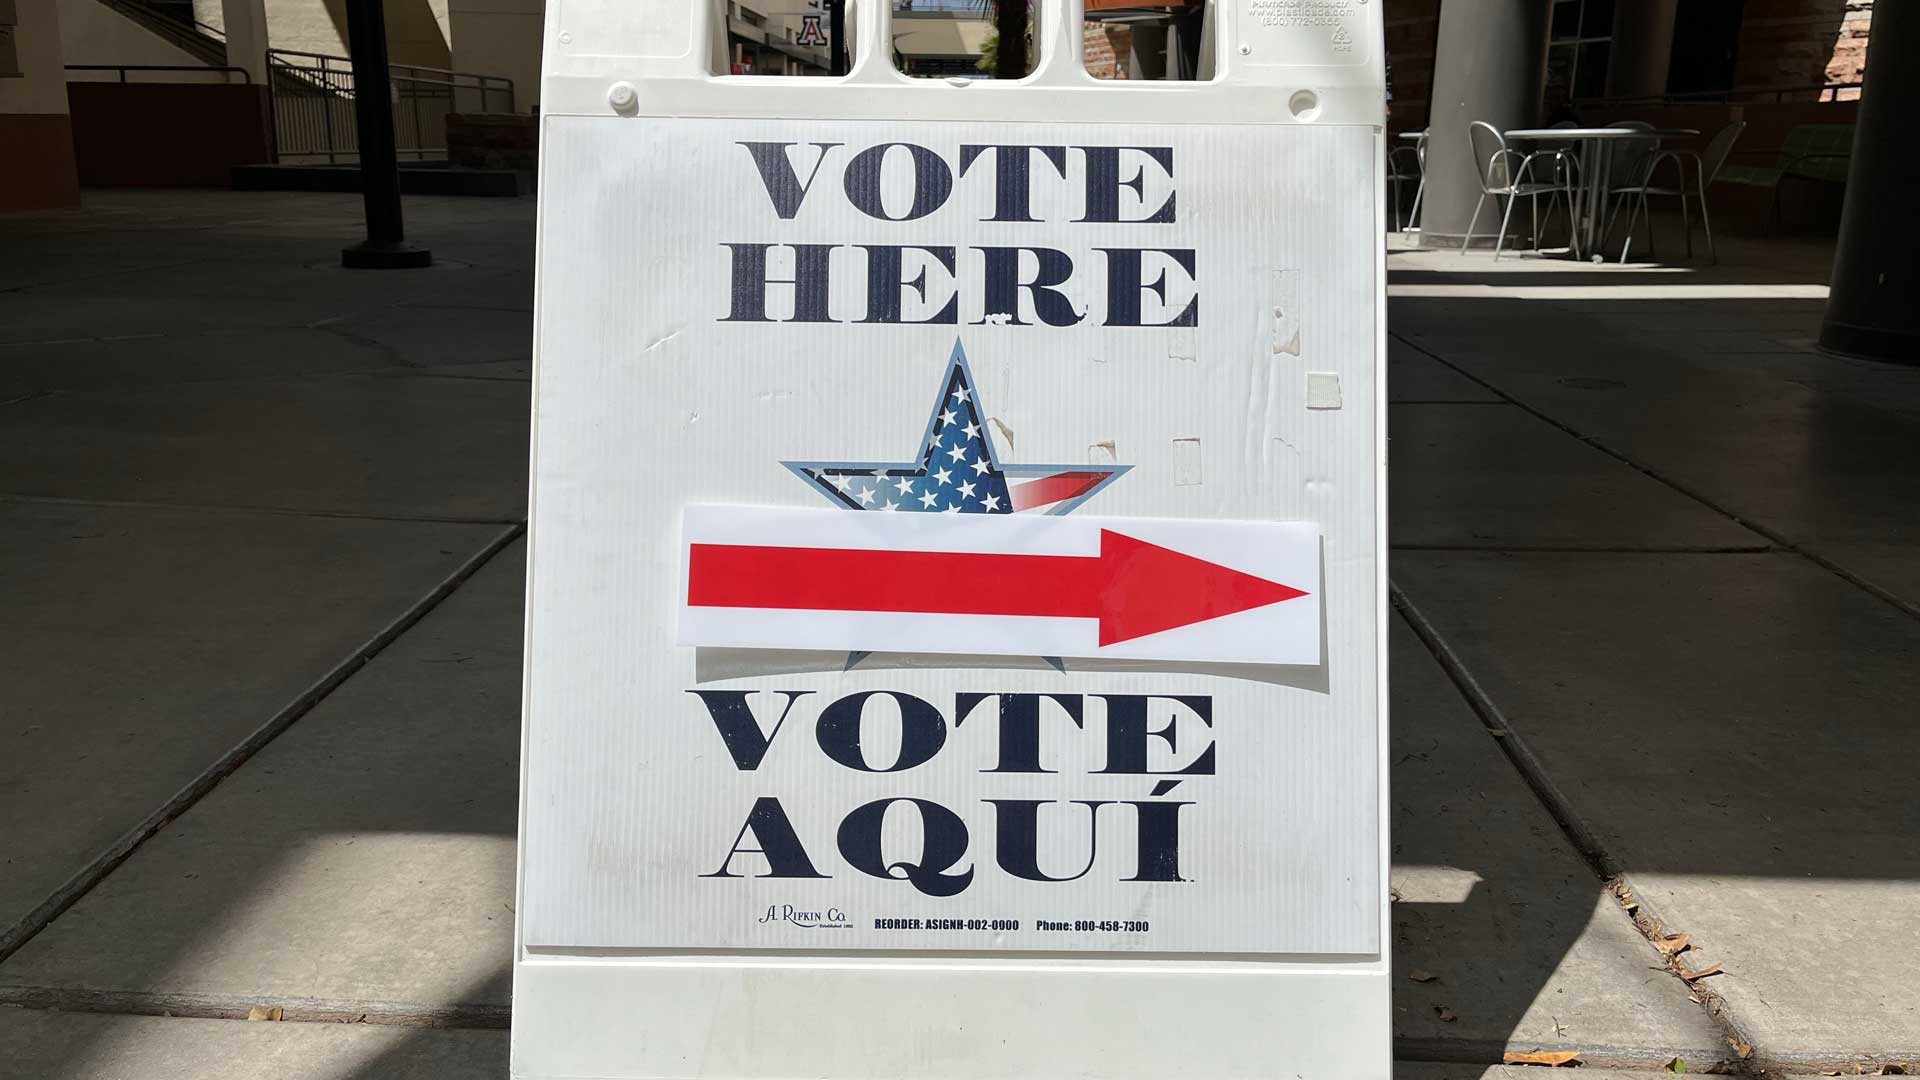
xmin=1421 ymin=0 xmax=1551 ymax=246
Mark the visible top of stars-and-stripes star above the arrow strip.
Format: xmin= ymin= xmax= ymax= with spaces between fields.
xmin=781 ymin=340 xmax=1131 ymax=515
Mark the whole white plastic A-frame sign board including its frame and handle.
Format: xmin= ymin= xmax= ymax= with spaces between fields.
xmin=513 ymin=0 xmax=1390 ymax=1080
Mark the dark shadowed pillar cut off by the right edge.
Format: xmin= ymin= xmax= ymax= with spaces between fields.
xmin=1820 ymin=2 xmax=1920 ymax=365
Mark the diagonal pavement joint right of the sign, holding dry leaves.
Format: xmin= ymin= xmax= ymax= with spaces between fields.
xmin=1388 ymin=582 xmax=1764 ymax=1076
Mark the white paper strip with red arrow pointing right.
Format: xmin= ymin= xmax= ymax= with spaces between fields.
xmin=680 ymin=507 xmax=1321 ymax=663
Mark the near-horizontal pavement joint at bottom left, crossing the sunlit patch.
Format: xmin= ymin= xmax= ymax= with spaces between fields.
xmin=0 ymin=986 xmax=511 ymax=1030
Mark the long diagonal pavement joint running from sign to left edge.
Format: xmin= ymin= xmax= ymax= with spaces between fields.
xmin=0 ymin=523 xmax=526 ymax=963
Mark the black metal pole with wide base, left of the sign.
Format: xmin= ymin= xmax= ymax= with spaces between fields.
xmin=340 ymin=0 xmax=434 ymax=269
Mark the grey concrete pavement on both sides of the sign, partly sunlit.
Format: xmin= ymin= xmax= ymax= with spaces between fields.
xmin=0 ymin=192 xmax=1920 ymax=1080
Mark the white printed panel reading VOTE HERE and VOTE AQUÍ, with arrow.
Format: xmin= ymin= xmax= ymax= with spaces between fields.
xmin=520 ymin=115 xmax=1382 ymax=957
